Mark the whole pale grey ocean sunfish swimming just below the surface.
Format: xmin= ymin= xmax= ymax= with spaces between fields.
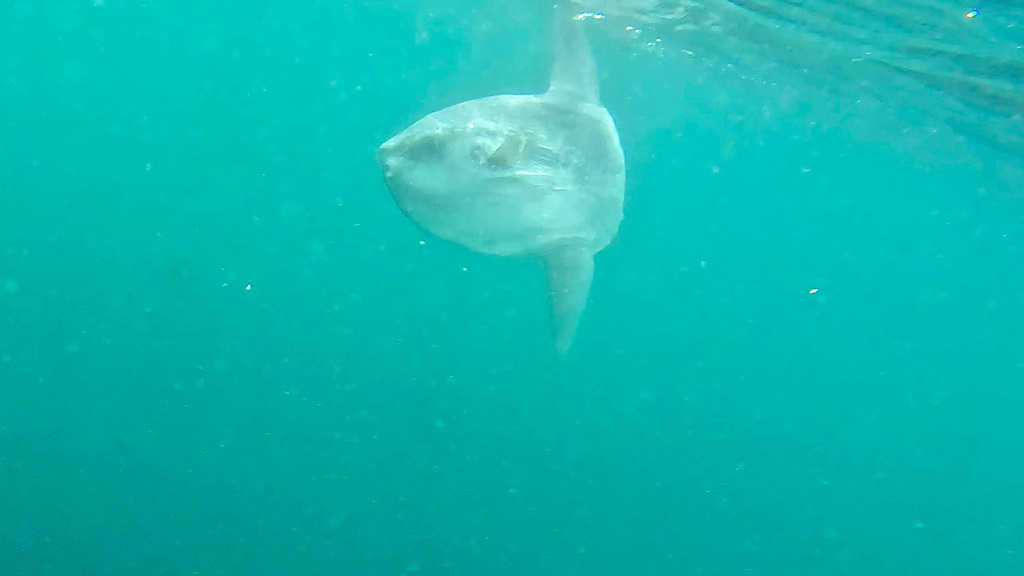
xmin=377 ymin=0 xmax=626 ymax=354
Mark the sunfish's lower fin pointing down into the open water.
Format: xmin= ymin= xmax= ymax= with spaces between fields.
xmin=544 ymin=247 xmax=594 ymax=354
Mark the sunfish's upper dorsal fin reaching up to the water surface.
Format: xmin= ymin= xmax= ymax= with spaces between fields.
xmin=548 ymin=0 xmax=600 ymax=104
